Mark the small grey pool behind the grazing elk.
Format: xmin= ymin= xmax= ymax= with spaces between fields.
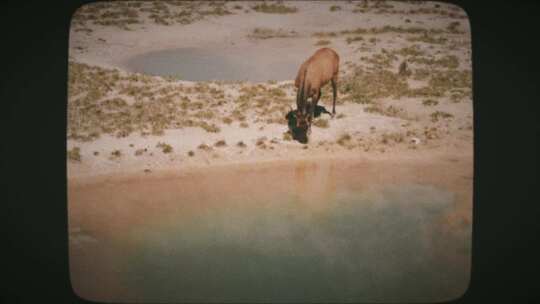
xmin=124 ymin=45 xmax=311 ymax=82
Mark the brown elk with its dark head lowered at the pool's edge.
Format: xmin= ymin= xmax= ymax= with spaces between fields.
xmin=287 ymin=48 xmax=339 ymax=142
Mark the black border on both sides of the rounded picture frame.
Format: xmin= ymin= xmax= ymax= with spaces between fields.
xmin=0 ymin=0 xmax=540 ymax=303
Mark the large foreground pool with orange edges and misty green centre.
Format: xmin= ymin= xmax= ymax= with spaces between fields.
xmin=69 ymin=159 xmax=470 ymax=303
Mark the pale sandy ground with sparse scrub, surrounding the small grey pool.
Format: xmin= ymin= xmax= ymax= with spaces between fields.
xmin=66 ymin=1 xmax=474 ymax=188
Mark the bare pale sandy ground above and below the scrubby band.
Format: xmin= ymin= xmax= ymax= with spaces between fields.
xmin=67 ymin=1 xmax=473 ymax=180
